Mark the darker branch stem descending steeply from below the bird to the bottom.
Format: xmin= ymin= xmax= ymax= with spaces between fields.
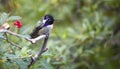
xmin=28 ymin=34 xmax=49 ymax=68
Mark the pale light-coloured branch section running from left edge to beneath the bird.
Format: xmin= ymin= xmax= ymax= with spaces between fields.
xmin=0 ymin=30 xmax=46 ymax=43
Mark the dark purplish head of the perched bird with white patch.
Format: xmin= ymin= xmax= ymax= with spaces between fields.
xmin=43 ymin=14 xmax=54 ymax=26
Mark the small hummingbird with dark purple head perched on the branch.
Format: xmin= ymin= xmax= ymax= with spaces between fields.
xmin=30 ymin=14 xmax=54 ymax=38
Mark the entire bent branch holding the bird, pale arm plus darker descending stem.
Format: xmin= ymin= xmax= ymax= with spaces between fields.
xmin=0 ymin=30 xmax=49 ymax=67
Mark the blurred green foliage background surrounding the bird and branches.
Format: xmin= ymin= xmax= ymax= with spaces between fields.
xmin=0 ymin=0 xmax=120 ymax=69
